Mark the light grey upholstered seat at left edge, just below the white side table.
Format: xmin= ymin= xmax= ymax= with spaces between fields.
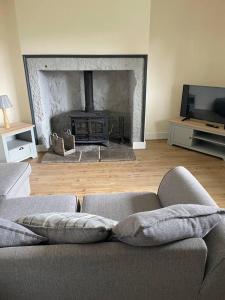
xmin=0 ymin=162 xmax=31 ymax=199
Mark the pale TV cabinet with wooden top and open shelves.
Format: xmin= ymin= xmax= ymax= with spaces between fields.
xmin=168 ymin=119 xmax=225 ymax=160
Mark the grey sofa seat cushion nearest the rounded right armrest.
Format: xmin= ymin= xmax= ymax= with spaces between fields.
xmin=81 ymin=192 xmax=161 ymax=221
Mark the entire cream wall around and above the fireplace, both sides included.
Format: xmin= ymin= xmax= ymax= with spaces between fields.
xmin=0 ymin=0 xmax=225 ymax=138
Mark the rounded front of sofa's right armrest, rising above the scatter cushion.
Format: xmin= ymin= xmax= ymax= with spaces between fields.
xmin=158 ymin=167 xmax=216 ymax=207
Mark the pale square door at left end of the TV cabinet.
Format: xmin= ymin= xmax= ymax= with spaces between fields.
xmin=172 ymin=126 xmax=193 ymax=147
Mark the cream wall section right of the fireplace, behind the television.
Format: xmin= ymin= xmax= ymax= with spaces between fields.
xmin=146 ymin=0 xmax=225 ymax=137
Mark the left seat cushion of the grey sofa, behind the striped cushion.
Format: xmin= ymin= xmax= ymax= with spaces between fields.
xmin=0 ymin=195 xmax=77 ymax=221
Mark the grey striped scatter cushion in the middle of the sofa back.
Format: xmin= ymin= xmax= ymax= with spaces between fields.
xmin=17 ymin=213 xmax=117 ymax=244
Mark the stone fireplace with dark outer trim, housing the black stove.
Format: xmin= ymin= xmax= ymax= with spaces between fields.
xmin=24 ymin=55 xmax=147 ymax=150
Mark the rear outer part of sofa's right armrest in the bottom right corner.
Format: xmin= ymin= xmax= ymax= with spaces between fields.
xmin=199 ymin=220 xmax=225 ymax=300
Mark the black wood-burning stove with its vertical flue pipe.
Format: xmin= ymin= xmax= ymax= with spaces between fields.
xmin=70 ymin=71 xmax=109 ymax=145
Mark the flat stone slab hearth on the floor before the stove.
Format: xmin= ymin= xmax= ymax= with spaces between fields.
xmin=42 ymin=142 xmax=136 ymax=163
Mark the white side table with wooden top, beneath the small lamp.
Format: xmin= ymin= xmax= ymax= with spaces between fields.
xmin=0 ymin=123 xmax=37 ymax=162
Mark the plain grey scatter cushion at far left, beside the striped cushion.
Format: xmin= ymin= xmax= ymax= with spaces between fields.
xmin=0 ymin=218 xmax=47 ymax=248
